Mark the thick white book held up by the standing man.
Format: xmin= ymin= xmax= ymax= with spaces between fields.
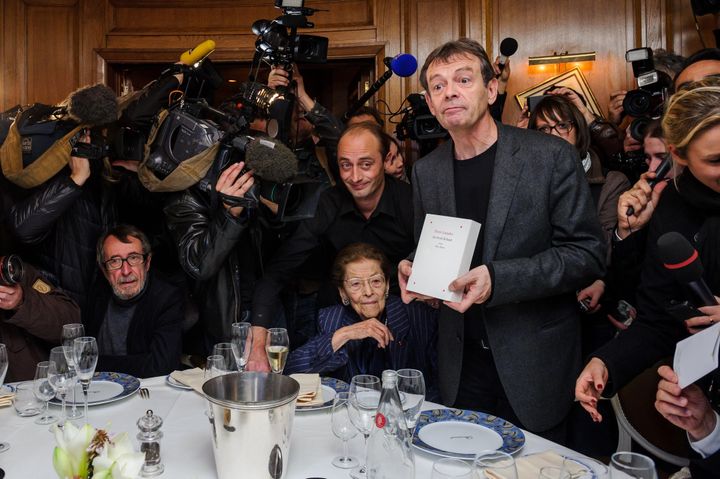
xmin=407 ymin=214 xmax=481 ymax=301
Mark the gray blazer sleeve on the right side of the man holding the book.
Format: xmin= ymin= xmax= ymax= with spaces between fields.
xmin=488 ymin=143 xmax=605 ymax=307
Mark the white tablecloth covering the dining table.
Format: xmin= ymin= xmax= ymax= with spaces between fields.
xmin=0 ymin=377 xmax=578 ymax=479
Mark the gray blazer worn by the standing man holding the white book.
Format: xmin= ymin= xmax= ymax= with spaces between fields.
xmin=412 ymin=123 xmax=605 ymax=431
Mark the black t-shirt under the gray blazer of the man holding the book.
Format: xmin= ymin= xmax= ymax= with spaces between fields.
xmin=453 ymin=142 xmax=497 ymax=345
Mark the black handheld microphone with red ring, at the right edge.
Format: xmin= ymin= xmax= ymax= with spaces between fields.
xmin=657 ymin=231 xmax=718 ymax=306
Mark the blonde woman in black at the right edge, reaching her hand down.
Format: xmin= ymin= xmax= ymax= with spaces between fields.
xmin=575 ymin=78 xmax=720 ymax=432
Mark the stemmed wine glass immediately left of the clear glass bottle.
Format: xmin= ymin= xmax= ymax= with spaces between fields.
xmin=348 ymin=374 xmax=380 ymax=479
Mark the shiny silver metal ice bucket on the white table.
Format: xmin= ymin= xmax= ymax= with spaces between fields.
xmin=203 ymin=372 xmax=300 ymax=479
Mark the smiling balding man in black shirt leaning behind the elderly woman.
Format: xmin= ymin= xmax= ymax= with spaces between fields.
xmin=249 ymin=122 xmax=414 ymax=370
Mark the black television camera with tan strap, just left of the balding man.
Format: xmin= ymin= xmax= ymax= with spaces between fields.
xmin=141 ymin=33 xmax=324 ymax=221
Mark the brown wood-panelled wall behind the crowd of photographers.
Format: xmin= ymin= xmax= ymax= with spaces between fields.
xmin=0 ymin=0 xmax=716 ymax=117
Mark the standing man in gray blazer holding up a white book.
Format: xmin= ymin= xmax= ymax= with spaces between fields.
xmin=399 ymin=39 xmax=605 ymax=443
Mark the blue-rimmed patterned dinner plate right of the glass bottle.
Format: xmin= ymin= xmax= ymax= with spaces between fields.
xmin=413 ymin=409 xmax=525 ymax=459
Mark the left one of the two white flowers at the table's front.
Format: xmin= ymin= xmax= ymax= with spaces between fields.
xmin=53 ymin=421 xmax=95 ymax=479
